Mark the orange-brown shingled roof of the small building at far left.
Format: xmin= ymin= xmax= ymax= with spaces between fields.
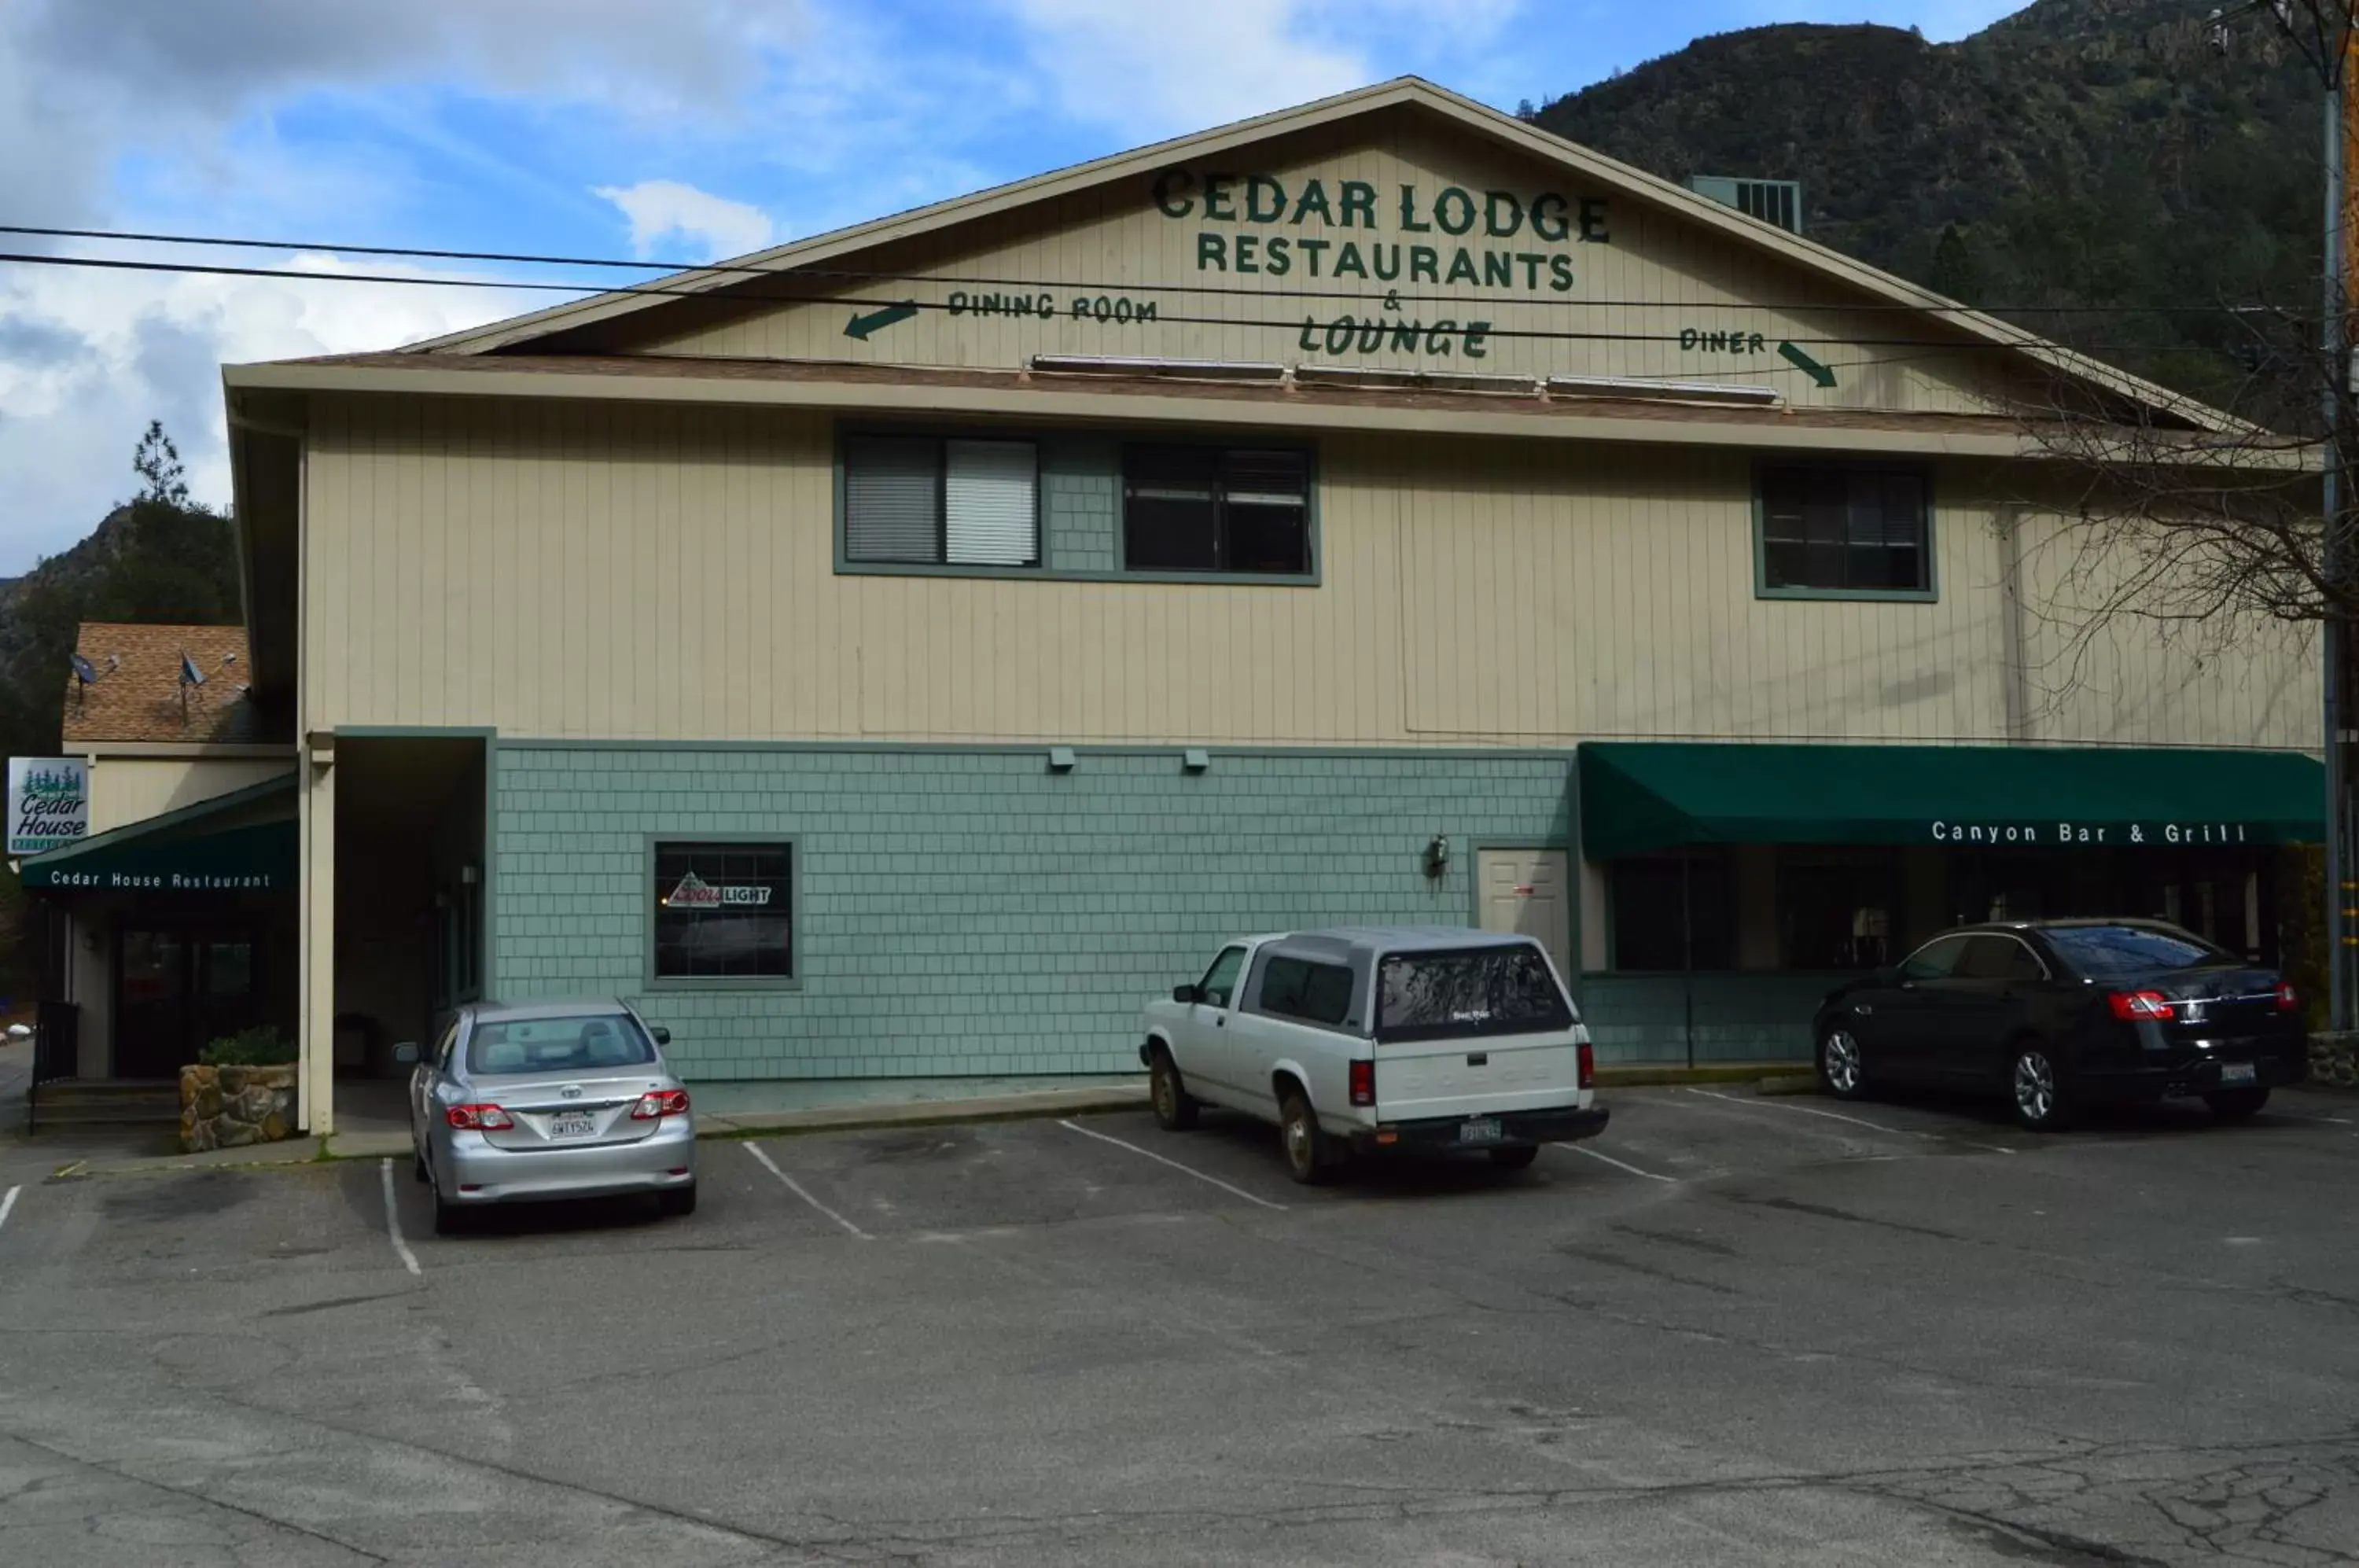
xmin=64 ymin=620 xmax=262 ymax=750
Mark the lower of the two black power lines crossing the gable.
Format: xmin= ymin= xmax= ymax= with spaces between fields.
xmin=0 ymin=252 xmax=2265 ymax=356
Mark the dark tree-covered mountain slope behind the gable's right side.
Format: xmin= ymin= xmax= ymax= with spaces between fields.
xmin=1533 ymin=0 xmax=2321 ymax=413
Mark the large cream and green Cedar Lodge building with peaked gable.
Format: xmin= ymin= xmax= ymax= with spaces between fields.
xmin=46 ymin=80 xmax=2321 ymax=1129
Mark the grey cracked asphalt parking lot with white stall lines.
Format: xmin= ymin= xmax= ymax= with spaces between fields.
xmin=0 ymin=1087 xmax=2359 ymax=1568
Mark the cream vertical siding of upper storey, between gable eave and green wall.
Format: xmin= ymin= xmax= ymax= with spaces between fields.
xmin=302 ymin=399 xmax=2317 ymax=748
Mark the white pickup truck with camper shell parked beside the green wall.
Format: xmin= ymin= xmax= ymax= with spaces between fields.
xmin=1139 ymin=926 xmax=1606 ymax=1181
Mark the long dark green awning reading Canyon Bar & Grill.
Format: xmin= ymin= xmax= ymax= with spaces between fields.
xmin=1581 ymin=741 xmax=2326 ymax=860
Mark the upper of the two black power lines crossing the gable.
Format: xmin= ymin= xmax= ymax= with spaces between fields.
xmin=0 ymin=224 xmax=2312 ymax=318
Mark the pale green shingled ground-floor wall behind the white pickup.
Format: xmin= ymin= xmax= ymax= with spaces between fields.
xmin=491 ymin=741 xmax=1571 ymax=1080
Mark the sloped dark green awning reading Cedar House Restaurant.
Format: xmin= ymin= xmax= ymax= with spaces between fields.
xmin=21 ymin=774 xmax=300 ymax=893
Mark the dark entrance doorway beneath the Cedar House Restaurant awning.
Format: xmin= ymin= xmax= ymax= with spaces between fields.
xmin=116 ymin=919 xmax=269 ymax=1077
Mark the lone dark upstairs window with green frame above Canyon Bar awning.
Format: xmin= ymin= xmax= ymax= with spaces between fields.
xmin=1760 ymin=467 xmax=1932 ymax=594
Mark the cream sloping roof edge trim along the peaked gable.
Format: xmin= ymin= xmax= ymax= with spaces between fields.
xmin=408 ymin=75 xmax=2250 ymax=432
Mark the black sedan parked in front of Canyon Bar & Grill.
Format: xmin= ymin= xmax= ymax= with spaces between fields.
xmin=1814 ymin=919 xmax=2307 ymax=1132
